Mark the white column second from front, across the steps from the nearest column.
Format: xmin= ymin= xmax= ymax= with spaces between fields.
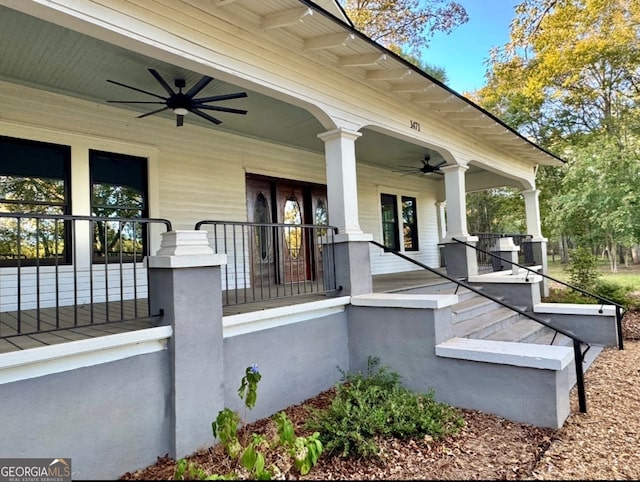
xmin=440 ymin=165 xmax=478 ymax=241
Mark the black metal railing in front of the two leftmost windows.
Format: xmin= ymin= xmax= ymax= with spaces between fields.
xmin=0 ymin=212 xmax=171 ymax=348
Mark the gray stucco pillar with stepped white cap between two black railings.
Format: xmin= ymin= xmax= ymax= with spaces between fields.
xmin=146 ymin=232 xmax=224 ymax=459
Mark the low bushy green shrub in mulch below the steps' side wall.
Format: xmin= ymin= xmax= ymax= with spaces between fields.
xmin=307 ymin=357 xmax=464 ymax=457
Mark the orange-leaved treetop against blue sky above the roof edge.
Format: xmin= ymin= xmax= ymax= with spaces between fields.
xmin=340 ymin=0 xmax=469 ymax=53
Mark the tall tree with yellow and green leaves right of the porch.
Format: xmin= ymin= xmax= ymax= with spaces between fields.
xmin=476 ymin=0 xmax=640 ymax=270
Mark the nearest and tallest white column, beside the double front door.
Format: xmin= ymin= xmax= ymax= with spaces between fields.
xmin=318 ymin=128 xmax=370 ymax=240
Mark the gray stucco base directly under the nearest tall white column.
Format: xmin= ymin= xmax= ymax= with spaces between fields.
xmin=333 ymin=241 xmax=373 ymax=296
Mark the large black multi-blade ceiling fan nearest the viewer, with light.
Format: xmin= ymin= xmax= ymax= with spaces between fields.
xmin=107 ymin=69 xmax=247 ymax=127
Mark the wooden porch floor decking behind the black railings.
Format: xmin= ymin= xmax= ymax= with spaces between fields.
xmin=0 ymin=270 xmax=444 ymax=353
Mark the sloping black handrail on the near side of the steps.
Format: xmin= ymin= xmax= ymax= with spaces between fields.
xmin=369 ymin=241 xmax=591 ymax=413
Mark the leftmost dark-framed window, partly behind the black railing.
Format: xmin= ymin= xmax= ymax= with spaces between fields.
xmin=0 ymin=136 xmax=71 ymax=266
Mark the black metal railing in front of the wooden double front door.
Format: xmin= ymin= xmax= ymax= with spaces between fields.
xmin=195 ymin=220 xmax=338 ymax=305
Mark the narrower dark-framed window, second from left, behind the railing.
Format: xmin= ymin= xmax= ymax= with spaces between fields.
xmin=89 ymin=150 xmax=148 ymax=261
